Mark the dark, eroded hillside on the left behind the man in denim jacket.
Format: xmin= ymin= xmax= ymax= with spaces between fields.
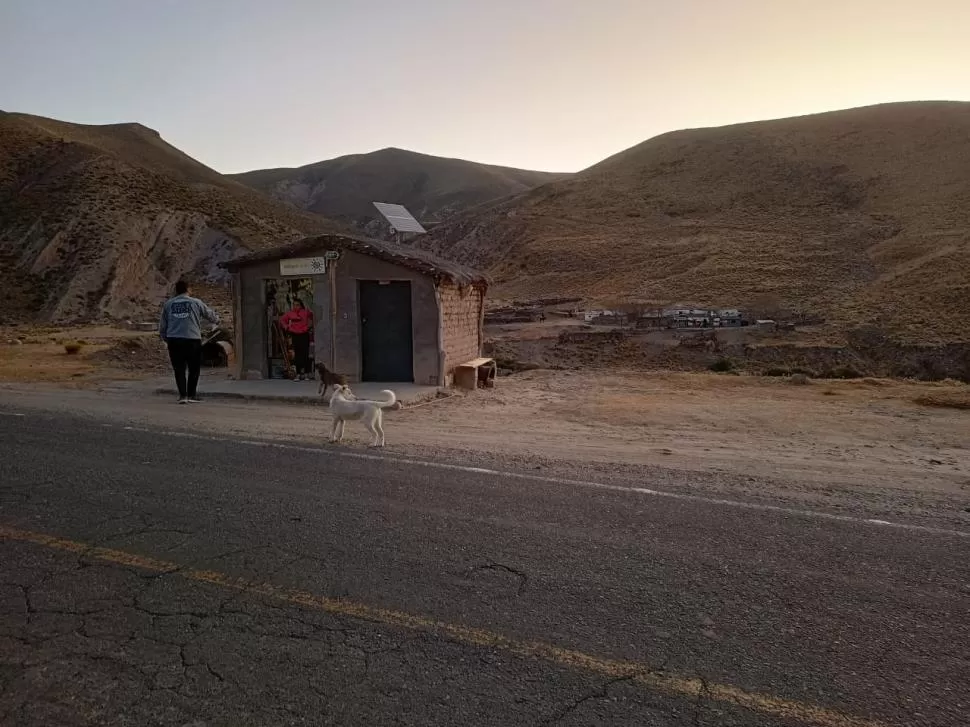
xmin=0 ymin=112 xmax=344 ymax=321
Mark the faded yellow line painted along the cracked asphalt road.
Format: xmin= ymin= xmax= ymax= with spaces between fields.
xmin=0 ymin=525 xmax=890 ymax=727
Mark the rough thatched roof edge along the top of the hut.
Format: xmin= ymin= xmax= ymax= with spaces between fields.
xmin=219 ymin=234 xmax=491 ymax=286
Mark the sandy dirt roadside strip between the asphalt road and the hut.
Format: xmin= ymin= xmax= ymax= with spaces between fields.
xmin=0 ymin=331 xmax=970 ymax=524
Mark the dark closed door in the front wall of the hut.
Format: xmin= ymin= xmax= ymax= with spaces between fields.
xmin=359 ymin=280 xmax=414 ymax=382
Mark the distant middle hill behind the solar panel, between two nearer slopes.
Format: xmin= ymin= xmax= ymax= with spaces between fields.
xmin=231 ymin=149 xmax=568 ymax=235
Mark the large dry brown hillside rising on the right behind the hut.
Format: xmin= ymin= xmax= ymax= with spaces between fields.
xmin=419 ymin=102 xmax=970 ymax=343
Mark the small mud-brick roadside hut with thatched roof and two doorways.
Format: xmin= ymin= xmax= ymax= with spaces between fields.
xmin=223 ymin=235 xmax=488 ymax=386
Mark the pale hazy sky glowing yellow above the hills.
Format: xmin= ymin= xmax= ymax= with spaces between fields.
xmin=0 ymin=0 xmax=970 ymax=172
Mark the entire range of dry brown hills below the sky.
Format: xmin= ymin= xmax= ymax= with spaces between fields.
xmin=0 ymin=102 xmax=970 ymax=343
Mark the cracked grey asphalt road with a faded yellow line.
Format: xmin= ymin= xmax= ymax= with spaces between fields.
xmin=0 ymin=410 xmax=970 ymax=727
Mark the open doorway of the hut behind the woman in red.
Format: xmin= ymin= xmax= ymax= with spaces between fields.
xmin=264 ymin=278 xmax=314 ymax=379
